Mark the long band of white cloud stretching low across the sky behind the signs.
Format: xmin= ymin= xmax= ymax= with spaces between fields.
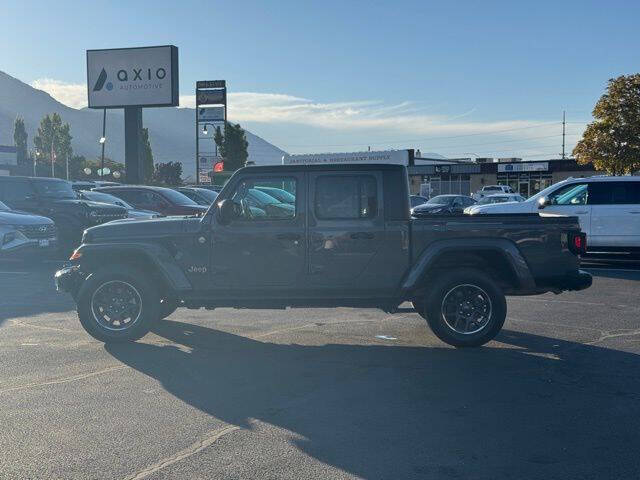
xmin=31 ymin=78 xmax=584 ymax=157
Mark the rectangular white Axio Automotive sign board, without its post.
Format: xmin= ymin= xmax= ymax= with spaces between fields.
xmin=87 ymin=45 xmax=178 ymax=108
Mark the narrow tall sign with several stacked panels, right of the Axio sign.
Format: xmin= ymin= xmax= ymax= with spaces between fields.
xmin=196 ymin=80 xmax=227 ymax=184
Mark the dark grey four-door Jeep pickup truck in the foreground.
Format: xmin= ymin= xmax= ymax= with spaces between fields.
xmin=55 ymin=164 xmax=591 ymax=347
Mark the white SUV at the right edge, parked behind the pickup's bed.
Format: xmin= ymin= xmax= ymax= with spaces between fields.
xmin=465 ymin=176 xmax=640 ymax=251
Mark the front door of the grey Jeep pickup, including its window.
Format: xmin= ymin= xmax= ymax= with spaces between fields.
xmin=210 ymin=173 xmax=307 ymax=288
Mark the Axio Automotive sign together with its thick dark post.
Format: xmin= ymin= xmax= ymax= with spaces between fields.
xmin=87 ymin=45 xmax=178 ymax=183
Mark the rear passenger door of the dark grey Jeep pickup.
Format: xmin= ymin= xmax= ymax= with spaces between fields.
xmin=308 ymin=171 xmax=385 ymax=296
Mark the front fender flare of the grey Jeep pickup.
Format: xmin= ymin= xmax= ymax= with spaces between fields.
xmin=77 ymin=243 xmax=192 ymax=291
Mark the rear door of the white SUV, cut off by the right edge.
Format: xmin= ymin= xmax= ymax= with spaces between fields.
xmin=587 ymin=181 xmax=640 ymax=248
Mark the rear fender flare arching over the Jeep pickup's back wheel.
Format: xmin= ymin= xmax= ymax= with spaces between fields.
xmin=401 ymin=238 xmax=536 ymax=296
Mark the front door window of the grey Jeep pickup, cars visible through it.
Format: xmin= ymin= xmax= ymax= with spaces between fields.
xmin=230 ymin=177 xmax=297 ymax=221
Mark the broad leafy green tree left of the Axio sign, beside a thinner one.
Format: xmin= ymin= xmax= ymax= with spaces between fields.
xmin=33 ymin=113 xmax=73 ymax=178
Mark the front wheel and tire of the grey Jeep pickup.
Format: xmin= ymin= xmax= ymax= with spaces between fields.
xmin=77 ymin=265 xmax=160 ymax=343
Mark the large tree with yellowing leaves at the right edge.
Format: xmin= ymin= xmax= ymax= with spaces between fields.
xmin=573 ymin=73 xmax=640 ymax=175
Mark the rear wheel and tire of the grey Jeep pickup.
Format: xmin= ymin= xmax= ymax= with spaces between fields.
xmin=419 ymin=268 xmax=507 ymax=347
